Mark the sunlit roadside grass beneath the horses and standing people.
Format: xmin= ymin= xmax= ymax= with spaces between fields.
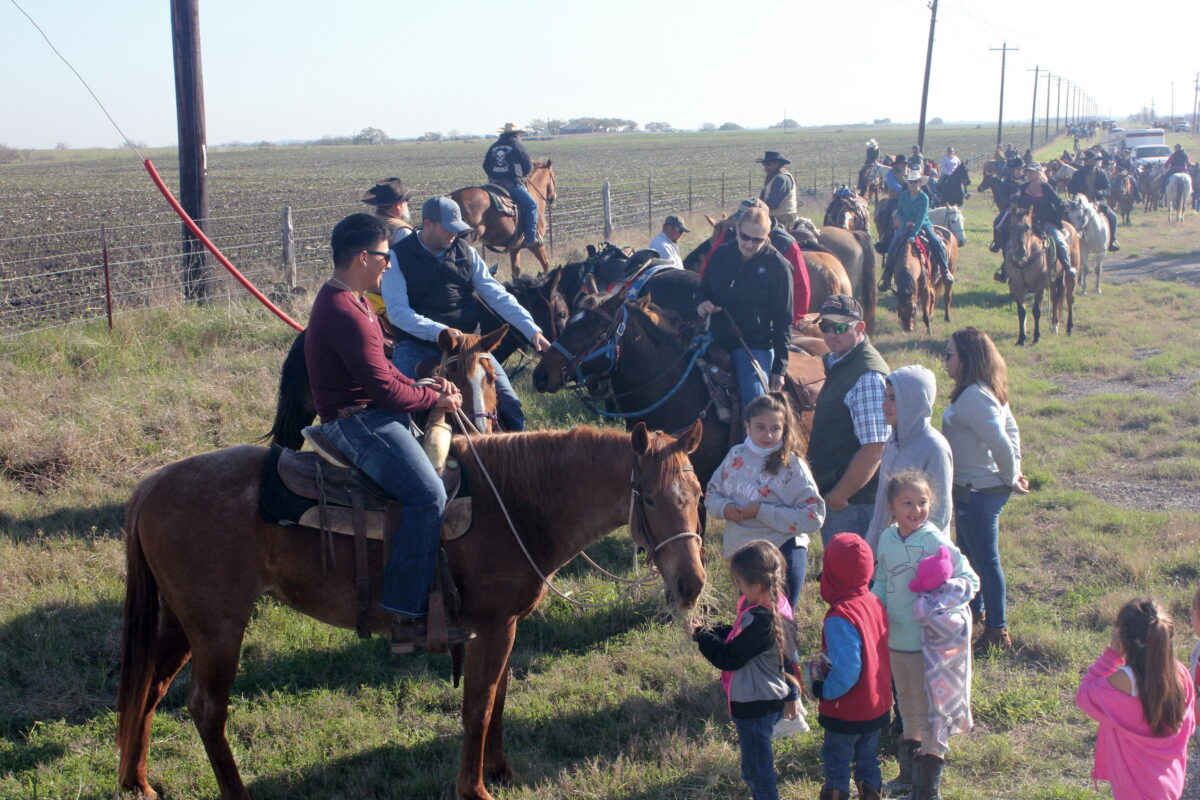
xmin=0 ymin=133 xmax=1200 ymax=800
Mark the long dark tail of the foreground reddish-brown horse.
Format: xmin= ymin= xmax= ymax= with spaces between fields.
xmin=116 ymin=476 xmax=160 ymax=775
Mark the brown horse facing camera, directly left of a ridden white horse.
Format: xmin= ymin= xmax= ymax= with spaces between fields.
xmin=1004 ymin=205 xmax=1079 ymax=344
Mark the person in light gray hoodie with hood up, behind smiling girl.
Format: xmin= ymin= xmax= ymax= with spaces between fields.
xmin=866 ymin=365 xmax=954 ymax=552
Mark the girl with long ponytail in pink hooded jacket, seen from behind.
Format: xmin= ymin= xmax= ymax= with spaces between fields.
xmin=1075 ymin=599 xmax=1195 ymax=800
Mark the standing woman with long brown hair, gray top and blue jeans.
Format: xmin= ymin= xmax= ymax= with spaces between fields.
xmin=942 ymin=327 xmax=1030 ymax=654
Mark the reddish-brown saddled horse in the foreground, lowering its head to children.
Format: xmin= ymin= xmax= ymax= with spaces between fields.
xmin=116 ymin=422 xmax=704 ymax=800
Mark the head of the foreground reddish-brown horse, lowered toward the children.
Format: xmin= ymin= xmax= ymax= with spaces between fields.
xmin=629 ymin=420 xmax=706 ymax=610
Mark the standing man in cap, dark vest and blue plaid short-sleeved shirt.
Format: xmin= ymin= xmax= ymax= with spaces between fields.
xmin=808 ymin=295 xmax=892 ymax=543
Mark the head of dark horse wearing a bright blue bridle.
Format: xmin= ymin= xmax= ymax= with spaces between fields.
xmin=533 ymin=294 xmax=628 ymax=393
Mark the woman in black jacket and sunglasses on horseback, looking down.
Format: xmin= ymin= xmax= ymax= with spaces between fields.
xmin=696 ymin=200 xmax=792 ymax=413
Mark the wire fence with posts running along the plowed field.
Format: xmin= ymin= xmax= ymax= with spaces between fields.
xmin=0 ymin=135 xmax=1032 ymax=347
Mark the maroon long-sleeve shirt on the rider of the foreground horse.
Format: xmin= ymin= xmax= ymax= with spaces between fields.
xmin=304 ymin=283 xmax=438 ymax=422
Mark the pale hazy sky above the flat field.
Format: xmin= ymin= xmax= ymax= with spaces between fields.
xmin=0 ymin=0 xmax=1200 ymax=148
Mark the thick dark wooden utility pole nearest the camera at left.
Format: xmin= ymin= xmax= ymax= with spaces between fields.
xmin=170 ymin=0 xmax=211 ymax=302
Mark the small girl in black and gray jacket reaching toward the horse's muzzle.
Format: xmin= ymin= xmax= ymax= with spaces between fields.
xmin=691 ymin=540 xmax=799 ymax=800
